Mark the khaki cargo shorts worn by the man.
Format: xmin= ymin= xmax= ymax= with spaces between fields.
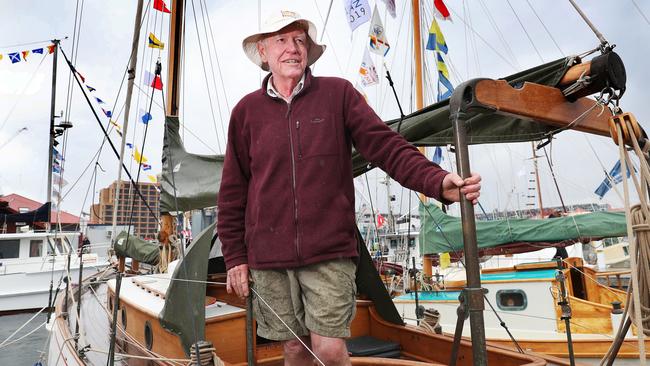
xmin=251 ymin=258 xmax=357 ymax=341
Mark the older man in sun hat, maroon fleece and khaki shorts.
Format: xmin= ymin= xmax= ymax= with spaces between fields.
xmin=217 ymin=11 xmax=481 ymax=366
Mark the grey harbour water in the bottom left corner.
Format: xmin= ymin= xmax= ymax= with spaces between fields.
xmin=0 ymin=313 xmax=48 ymax=366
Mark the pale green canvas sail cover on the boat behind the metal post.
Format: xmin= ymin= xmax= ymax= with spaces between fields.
xmin=420 ymin=203 xmax=627 ymax=254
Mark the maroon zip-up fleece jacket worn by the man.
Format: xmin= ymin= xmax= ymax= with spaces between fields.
xmin=217 ymin=69 xmax=448 ymax=269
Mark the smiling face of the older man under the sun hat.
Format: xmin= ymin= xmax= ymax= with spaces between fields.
xmin=257 ymin=24 xmax=308 ymax=80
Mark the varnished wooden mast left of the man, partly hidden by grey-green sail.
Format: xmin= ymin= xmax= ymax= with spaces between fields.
xmin=158 ymin=0 xmax=185 ymax=263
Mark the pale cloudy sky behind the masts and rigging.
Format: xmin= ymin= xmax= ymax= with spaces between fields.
xmin=0 ymin=0 xmax=650 ymax=220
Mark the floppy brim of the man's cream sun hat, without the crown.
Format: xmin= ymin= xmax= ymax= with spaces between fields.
xmin=242 ymin=19 xmax=326 ymax=71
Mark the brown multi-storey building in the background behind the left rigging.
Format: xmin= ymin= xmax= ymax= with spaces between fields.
xmin=90 ymin=181 xmax=160 ymax=239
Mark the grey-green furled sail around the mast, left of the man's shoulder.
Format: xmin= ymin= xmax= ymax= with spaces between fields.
xmin=160 ymin=116 xmax=224 ymax=212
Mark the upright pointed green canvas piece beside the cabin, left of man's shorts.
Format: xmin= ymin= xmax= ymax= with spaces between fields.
xmin=160 ymin=224 xmax=215 ymax=355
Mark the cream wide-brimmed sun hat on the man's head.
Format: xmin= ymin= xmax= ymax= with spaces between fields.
xmin=242 ymin=10 xmax=325 ymax=71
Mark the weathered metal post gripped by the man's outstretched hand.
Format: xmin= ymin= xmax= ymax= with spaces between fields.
xmin=449 ymin=95 xmax=487 ymax=365
